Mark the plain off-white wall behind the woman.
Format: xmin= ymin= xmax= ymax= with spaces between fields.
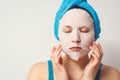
xmin=0 ymin=0 xmax=120 ymax=80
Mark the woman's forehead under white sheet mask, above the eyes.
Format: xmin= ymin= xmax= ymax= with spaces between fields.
xmin=60 ymin=9 xmax=93 ymax=26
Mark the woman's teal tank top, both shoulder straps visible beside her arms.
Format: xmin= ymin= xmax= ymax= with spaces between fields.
xmin=48 ymin=60 xmax=102 ymax=80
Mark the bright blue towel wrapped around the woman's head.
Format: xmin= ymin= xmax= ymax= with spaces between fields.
xmin=54 ymin=0 xmax=101 ymax=40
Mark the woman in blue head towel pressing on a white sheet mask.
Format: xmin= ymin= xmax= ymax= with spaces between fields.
xmin=28 ymin=0 xmax=120 ymax=80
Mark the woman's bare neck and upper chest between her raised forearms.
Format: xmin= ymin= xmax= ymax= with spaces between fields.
xmin=63 ymin=55 xmax=89 ymax=80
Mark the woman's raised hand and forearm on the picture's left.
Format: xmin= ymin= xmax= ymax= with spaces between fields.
xmin=50 ymin=45 xmax=69 ymax=80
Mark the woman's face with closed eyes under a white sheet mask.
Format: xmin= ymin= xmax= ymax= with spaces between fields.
xmin=59 ymin=9 xmax=94 ymax=61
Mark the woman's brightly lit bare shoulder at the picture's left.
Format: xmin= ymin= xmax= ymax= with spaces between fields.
xmin=27 ymin=62 xmax=48 ymax=80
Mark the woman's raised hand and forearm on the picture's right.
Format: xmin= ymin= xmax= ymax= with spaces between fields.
xmin=83 ymin=42 xmax=103 ymax=80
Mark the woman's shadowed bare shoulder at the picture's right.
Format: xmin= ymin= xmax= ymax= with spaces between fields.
xmin=100 ymin=64 xmax=120 ymax=80
